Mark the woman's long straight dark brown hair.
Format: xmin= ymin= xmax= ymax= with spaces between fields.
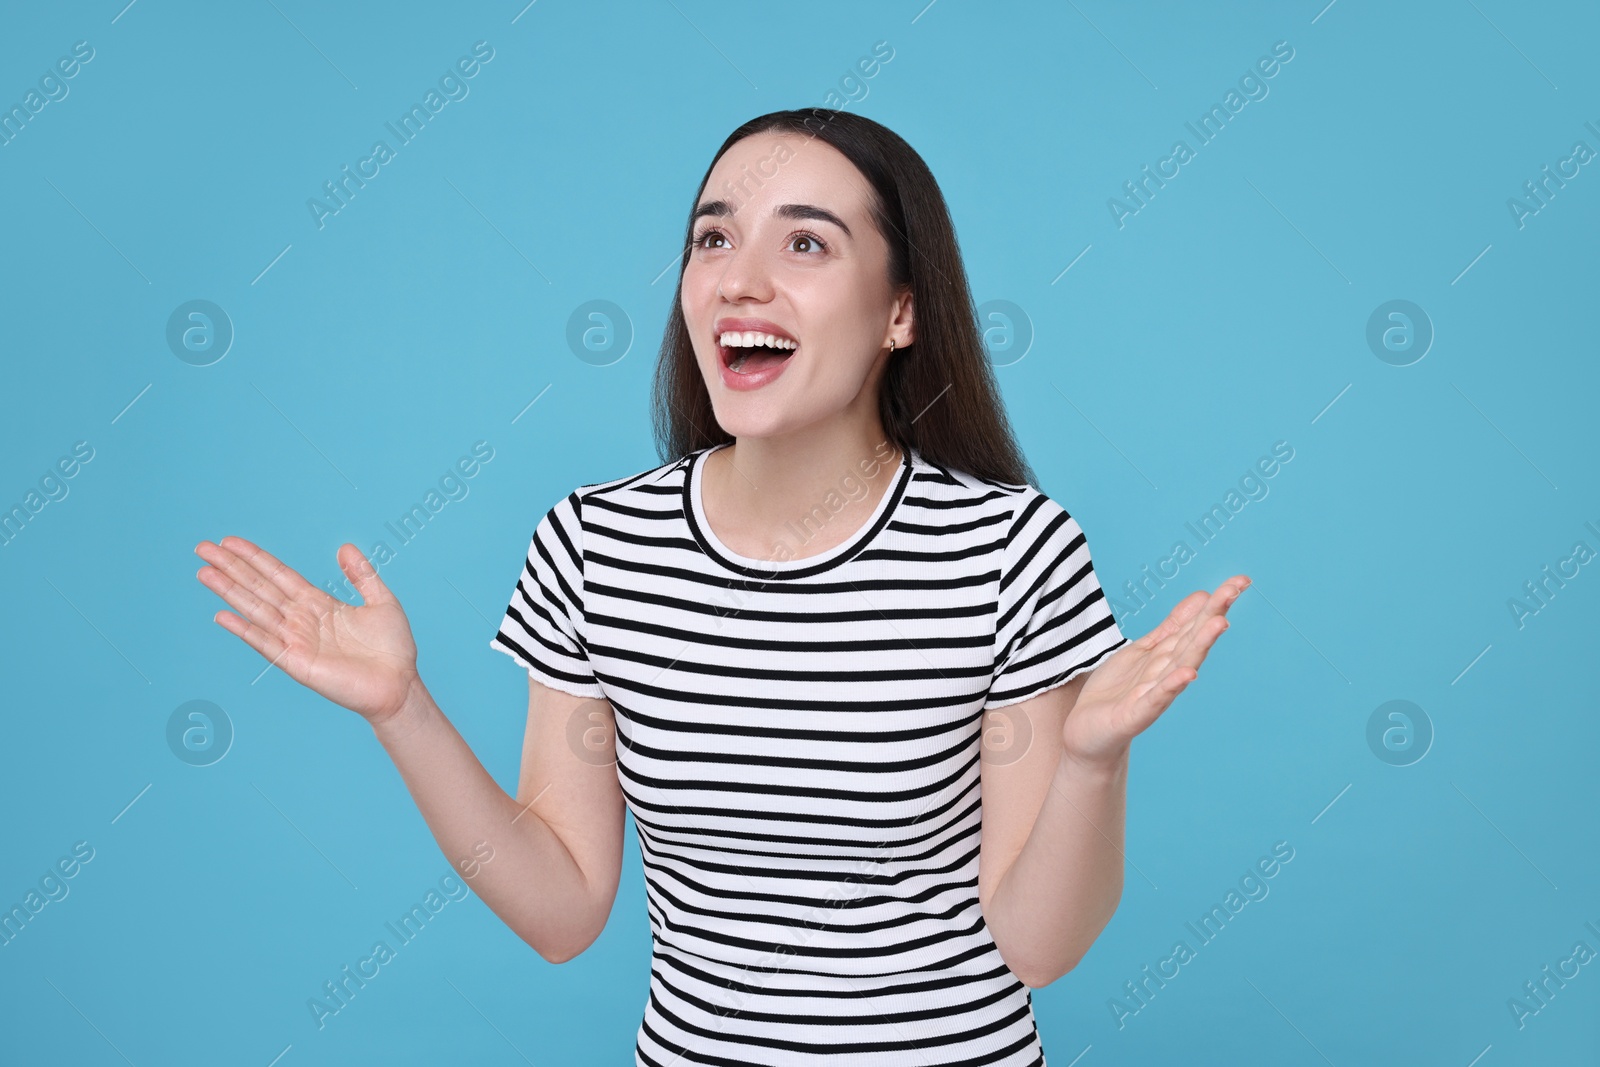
xmin=653 ymin=107 xmax=1037 ymax=488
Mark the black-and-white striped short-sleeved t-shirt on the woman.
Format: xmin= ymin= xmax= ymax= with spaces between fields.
xmin=491 ymin=445 xmax=1126 ymax=1067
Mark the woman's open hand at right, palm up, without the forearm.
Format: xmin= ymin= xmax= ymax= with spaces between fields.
xmin=1061 ymin=574 xmax=1250 ymax=765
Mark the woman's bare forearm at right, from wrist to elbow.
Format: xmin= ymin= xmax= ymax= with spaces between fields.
xmin=984 ymin=749 xmax=1128 ymax=987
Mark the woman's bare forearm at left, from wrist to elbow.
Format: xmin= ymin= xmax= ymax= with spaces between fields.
xmin=373 ymin=680 xmax=611 ymax=963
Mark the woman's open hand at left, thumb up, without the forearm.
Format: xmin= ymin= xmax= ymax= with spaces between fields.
xmin=195 ymin=537 xmax=419 ymax=726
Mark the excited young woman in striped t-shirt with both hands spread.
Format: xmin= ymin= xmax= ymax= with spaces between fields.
xmin=197 ymin=110 xmax=1250 ymax=1067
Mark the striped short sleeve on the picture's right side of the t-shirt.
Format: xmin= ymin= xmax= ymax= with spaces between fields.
xmin=984 ymin=490 xmax=1128 ymax=710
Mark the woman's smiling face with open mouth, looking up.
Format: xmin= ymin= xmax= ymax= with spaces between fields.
xmin=683 ymin=131 xmax=914 ymax=437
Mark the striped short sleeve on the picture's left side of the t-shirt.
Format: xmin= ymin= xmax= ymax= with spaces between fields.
xmin=490 ymin=493 xmax=605 ymax=697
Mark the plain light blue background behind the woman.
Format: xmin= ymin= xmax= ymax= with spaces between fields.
xmin=0 ymin=0 xmax=1600 ymax=1067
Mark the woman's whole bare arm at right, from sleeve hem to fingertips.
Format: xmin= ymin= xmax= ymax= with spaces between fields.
xmin=978 ymin=574 xmax=1250 ymax=987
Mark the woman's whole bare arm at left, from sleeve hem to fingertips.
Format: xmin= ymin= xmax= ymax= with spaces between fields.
xmin=195 ymin=537 xmax=624 ymax=963
